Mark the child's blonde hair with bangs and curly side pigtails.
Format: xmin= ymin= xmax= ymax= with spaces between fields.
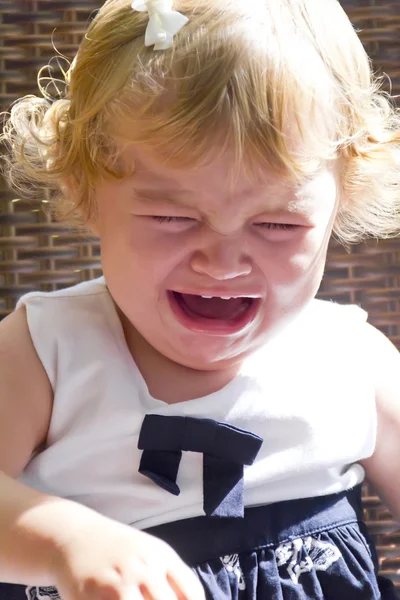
xmin=0 ymin=0 xmax=400 ymax=243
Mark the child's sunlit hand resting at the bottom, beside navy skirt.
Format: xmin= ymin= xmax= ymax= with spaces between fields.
xmin=53 ymin=514 xmax=205 ymax=600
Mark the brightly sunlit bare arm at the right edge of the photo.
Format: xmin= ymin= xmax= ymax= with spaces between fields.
xmin=361 ymin=325 xmax=400 ymax=522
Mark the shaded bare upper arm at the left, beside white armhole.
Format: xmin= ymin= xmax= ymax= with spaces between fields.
xmin=0 ymin=307 xmax=53 ymax=477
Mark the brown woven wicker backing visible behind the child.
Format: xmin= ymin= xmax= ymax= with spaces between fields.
xmin=0 ymin=0 xmax=400 ymax=585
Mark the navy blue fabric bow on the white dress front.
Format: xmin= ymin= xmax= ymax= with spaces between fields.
xmin=138 ymin=415 xmax=263 ymax=517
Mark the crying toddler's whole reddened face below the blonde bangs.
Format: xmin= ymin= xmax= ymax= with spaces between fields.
xmin=97 ymin=149 xmax=338 ymax=369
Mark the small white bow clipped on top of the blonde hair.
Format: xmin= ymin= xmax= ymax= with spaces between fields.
xmin=132 ymin=0 xmax=189 ymax=50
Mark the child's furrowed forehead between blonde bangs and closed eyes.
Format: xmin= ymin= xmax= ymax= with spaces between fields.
xmin=124 ymin=144 xmax=336 ymax=213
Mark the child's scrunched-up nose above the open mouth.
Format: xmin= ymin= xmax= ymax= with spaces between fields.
xmin=191 ymin=233 xmax=252 ymax=281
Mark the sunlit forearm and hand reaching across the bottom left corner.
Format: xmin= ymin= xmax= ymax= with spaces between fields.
xmin=0 ymin=473 xmax=205 ymax=600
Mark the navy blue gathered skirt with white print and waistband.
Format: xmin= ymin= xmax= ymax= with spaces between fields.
xmin=0 ymin=486 xmax=400 ymax=600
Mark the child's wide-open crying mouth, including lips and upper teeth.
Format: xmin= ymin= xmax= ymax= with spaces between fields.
xmin=168 ymin=291 xmax=261 ymax=333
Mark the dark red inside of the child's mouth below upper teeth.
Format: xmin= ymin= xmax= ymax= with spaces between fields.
xmin=176 ymin=294 xmax=250 ymax=321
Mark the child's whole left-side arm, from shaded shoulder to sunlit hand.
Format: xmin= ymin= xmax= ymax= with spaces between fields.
xmin=0 ymin=309 xmax=204 ymax=600
